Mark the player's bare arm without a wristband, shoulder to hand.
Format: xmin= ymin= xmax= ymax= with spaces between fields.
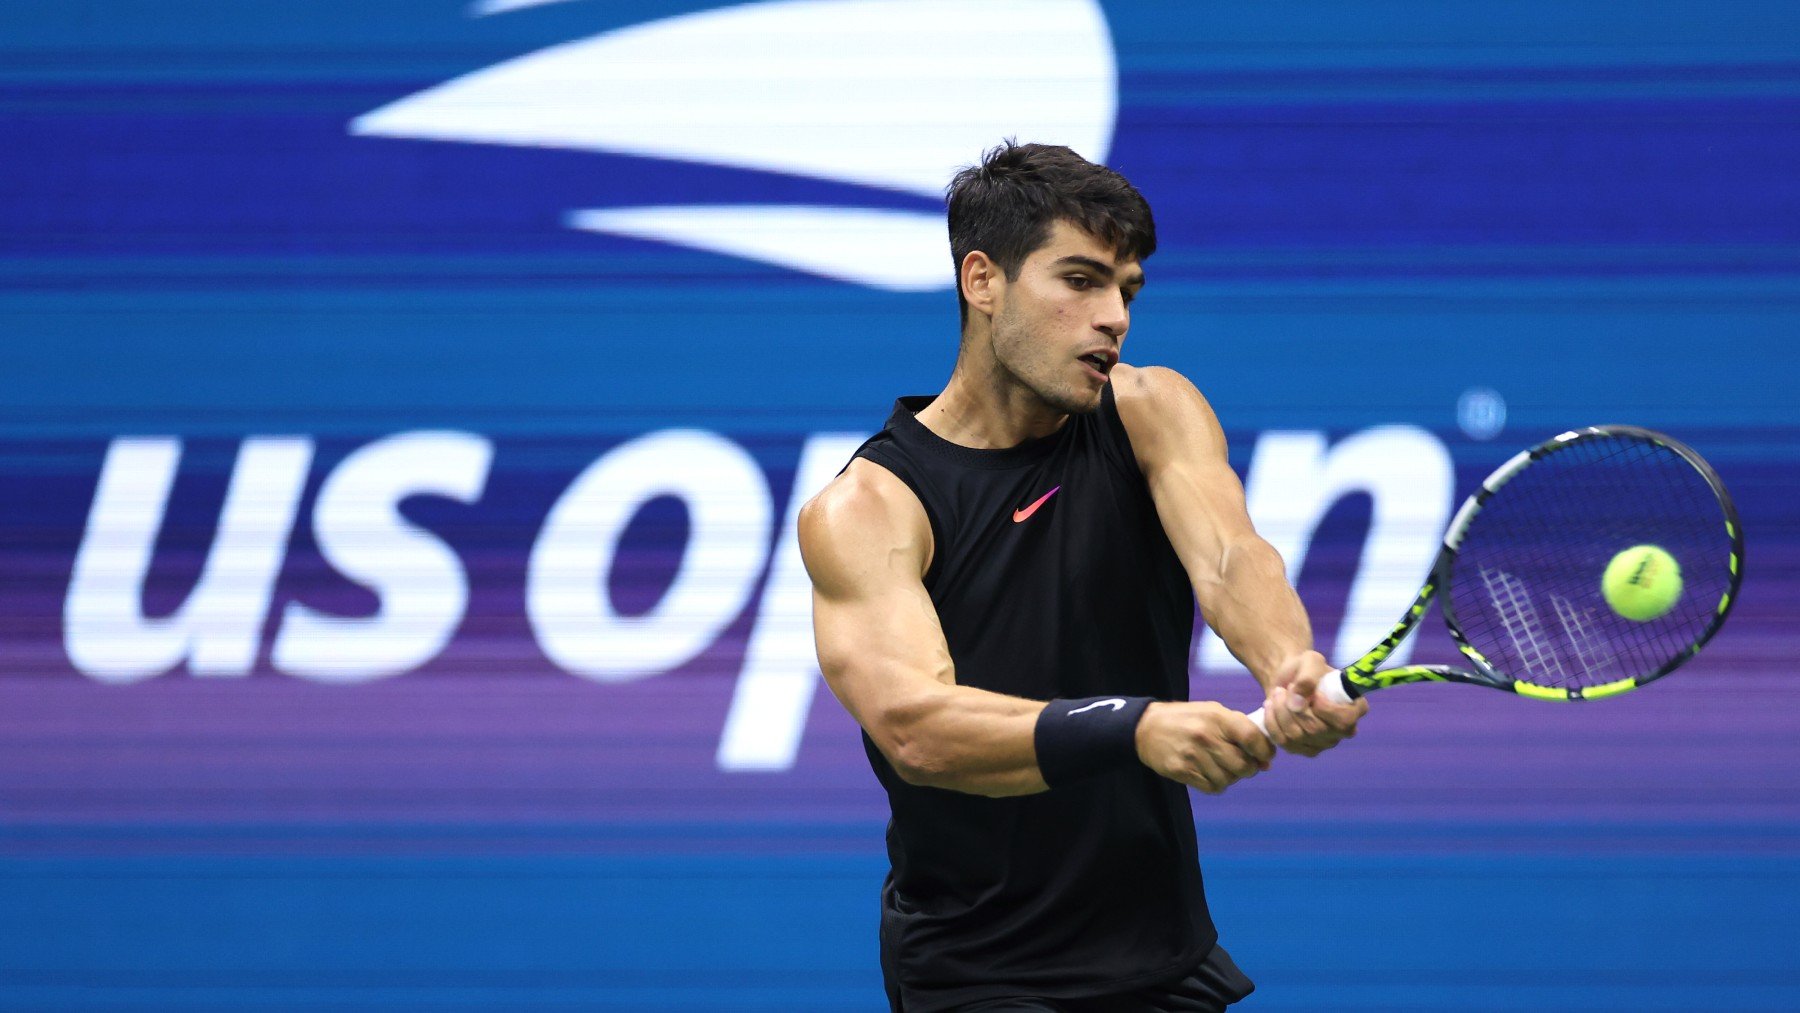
xmin=1112 ymin=365 xmax=1368 ymax=754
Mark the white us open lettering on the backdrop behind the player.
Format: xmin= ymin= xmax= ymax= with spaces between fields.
xmin=63 ymin=426 xmax=1454 ymax=770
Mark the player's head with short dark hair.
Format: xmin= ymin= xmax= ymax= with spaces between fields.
xmin=949 ymin=142 xmax=1156 ymax=412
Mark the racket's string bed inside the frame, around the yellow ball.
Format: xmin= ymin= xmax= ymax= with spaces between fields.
xmin=1445 ymin=435 xmax=1730 ymax=687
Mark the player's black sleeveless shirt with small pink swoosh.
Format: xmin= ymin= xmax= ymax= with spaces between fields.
xmin=857 ymin=385 xmax=1217 ymax=1011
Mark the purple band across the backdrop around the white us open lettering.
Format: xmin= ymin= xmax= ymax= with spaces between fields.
xmin=0 ymin=441 xmax=1800 ymax=855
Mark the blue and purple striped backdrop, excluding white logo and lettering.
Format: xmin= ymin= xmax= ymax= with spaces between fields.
xmin=0 ymin=0 xmax=1800 ymax=1009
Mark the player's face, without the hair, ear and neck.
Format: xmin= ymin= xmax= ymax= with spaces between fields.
xmin=994 ymin=221 xmax=1143 ymax=414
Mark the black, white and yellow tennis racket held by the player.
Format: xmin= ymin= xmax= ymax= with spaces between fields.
xmin=1249 ymin=426 xmax=1744 ymax=734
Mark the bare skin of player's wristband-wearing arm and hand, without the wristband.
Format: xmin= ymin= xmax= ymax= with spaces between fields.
xmin=799 ymin=461 xmax=1269 ymax=797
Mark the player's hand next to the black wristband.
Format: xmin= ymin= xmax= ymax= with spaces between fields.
xmin=1138 ymin=702 xmax=1274 ymax=795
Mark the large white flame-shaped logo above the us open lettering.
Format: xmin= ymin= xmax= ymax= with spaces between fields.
xmin=349 ymin=0 xmax=1118 ymax=291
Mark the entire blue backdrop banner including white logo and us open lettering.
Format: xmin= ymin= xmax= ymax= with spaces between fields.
xmin=0 ymin=0 xmax=1800 ymax=1009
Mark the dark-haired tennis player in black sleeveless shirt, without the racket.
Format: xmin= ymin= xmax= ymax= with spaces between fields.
xmin=799 ymin=142 xmax=1366 ymax=1013
